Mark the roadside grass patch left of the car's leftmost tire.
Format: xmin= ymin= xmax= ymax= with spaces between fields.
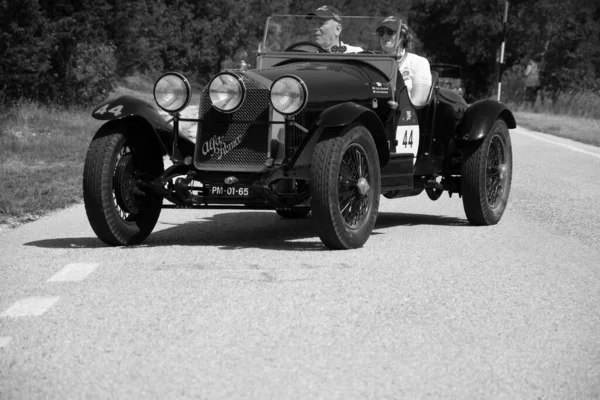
xmin=0 ymin=102 xmax=101 ymax=225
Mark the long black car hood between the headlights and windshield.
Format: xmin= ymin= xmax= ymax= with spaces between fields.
xmin=246 ymin=62 xmax=391 ymax=103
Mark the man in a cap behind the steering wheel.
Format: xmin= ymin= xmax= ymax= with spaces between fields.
xmin=306 ymin=6 xmax=363 ymax=53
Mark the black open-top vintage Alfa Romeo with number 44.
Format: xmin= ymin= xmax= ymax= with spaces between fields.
xmin=83 ymin=16 xmax=516 ymax=249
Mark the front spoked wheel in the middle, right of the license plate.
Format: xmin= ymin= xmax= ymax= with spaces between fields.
xmin=310 ymin=125 xmax=381 ymax=249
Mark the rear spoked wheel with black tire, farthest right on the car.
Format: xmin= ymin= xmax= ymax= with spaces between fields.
xmin=461 ymin=119 xmax=512 ymax=225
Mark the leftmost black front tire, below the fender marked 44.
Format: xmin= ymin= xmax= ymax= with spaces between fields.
xmin=83 ymin=123 xmax=164 ymax=246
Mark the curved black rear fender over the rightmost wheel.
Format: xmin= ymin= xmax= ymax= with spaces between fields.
xmin=455 ymin=99 xmax=517 ymax=142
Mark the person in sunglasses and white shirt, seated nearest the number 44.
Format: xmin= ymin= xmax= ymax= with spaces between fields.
xmin=377 ymin=16 xmax=431 ymax=106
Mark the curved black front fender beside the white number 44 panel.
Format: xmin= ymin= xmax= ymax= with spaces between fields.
xmin=316 ymin=102 xmax=390 ymax=167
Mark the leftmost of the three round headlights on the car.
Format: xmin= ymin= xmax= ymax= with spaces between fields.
xmin=154 ymin=72 xmax=192 ymax=113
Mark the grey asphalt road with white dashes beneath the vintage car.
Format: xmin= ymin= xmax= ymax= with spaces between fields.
xmin=0 ymin=129 xmax=600 ymax=400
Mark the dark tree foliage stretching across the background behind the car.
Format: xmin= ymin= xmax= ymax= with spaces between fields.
xmin=0 ymin=0 xmax=600 ymax=105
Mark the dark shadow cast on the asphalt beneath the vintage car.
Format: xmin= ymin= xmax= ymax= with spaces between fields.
xmin=25 ymin=211 xmax=469 ymax=251
